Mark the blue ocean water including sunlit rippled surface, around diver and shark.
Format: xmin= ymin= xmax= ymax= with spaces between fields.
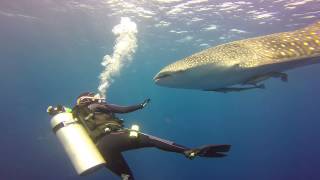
xmin=0 ymin=0 xmax=320 ymax=180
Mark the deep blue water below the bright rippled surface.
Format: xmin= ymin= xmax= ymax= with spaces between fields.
xmin=0 ymin=1 xmax=320 ymax=180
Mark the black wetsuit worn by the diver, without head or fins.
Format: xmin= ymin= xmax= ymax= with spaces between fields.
xmin=74 ymin=103 xmax=188 ymax=180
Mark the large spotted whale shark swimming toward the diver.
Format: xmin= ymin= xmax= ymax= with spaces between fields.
xmin=153 ymin=21 xmax=320 ymax=93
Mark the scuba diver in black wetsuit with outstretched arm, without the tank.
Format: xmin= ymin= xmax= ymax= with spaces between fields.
xmin=48 ymin=92 xmax=230 ymax=180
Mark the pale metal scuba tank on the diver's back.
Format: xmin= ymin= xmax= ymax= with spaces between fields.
xmin=51 ymin=112 xmax=106 ymax=176
